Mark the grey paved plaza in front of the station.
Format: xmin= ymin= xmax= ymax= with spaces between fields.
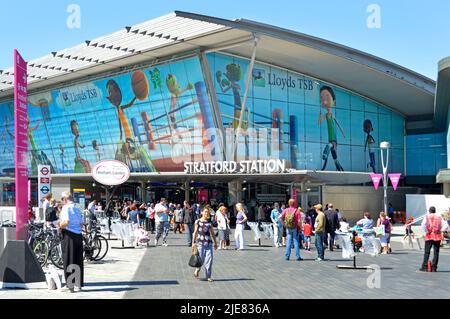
xmin=0 ymin=226 xmax=450 ymax=299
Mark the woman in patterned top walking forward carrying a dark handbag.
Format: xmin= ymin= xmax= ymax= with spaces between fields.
xmin=192 ymin=207 xmax=217 ymax=282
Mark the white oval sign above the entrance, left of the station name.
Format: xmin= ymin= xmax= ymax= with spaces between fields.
xmin=92 ymin=160 xmax=130 ymax=186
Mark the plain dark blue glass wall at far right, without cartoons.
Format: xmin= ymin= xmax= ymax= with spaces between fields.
xmin=406 ymin=133 xmax=447 ymax=176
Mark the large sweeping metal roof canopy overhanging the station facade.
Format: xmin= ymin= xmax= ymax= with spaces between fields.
xmin=0 ymin=11 xmax=436 ymax=121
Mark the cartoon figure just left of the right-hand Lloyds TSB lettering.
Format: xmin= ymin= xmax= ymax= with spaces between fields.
xmin=216 ymin=63 xmax=248 ymax=129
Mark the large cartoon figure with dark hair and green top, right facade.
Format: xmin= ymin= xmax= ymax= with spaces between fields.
xmin=319 ymin=86 xmax=345 ymax=171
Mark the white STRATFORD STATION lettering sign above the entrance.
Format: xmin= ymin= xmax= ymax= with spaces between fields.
xmin=184 ymin=160 xmax=288 ymax=175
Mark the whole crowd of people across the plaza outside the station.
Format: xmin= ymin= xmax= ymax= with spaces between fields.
xmin=34 ymin=193 xmax=448 ymax=291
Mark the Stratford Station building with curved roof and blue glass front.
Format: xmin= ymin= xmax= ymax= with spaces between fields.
xmin=0 ymin=11 xmax=450 ymax=219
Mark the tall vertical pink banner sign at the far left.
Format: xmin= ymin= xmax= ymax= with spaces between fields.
xmin=14 ymin=50 xmax=28 ymax=240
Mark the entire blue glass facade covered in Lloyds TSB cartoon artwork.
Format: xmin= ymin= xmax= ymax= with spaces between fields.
xmin=0 ymin=53 xmax=405 ymax=176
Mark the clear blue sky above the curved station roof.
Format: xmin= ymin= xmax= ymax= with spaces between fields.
xmin=0 ymin=0 xmax=450 ymax=80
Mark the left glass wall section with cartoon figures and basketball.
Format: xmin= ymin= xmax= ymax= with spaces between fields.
xmin=0 ymin=57 xmax=220 ymax=176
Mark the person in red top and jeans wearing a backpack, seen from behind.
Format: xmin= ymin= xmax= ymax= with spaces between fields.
xmin=278 ymin=199 xmax=302 ymax=261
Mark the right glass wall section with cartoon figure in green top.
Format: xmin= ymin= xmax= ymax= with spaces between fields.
xmin=208 ymin=53 xmax=405 ymax=173
